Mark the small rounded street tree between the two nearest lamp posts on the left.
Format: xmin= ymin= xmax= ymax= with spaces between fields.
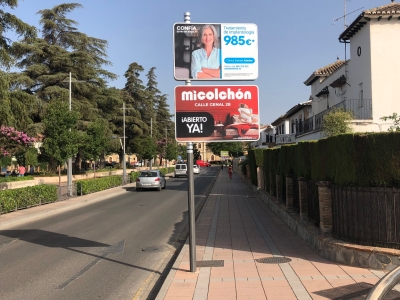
xmin=83 ymin=119 xmax=110 ymax=177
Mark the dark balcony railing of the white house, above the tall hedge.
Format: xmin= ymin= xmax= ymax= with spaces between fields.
xmin=314 ymin=99 xmax=372 ymax=130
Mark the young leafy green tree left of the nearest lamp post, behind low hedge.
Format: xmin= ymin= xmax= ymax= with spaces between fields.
xmin=43 ymin=100 xmax=83 ymax=185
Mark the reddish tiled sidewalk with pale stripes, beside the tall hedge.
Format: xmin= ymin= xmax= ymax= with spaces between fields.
xmin=156 ymin=169 xmax=400 ymax=300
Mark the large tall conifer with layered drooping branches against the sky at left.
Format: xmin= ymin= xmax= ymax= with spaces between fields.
xmin=12 ymin=3 xmax=116 ymax=130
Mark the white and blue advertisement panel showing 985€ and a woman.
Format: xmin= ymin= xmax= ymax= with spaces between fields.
xmin=173 ymin=23 xmax=258 ymax=80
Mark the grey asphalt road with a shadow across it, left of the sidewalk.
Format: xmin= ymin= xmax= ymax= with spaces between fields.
xmin=0 ymin=167 xmax=219 ymax=300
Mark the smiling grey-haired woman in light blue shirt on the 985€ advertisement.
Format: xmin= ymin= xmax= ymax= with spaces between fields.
xmin=191 ymin=24 xmax=221 ymax=79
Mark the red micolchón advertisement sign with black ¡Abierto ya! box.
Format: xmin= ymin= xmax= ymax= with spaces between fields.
xmin=175 ymin=85 xmax=260 ymax=142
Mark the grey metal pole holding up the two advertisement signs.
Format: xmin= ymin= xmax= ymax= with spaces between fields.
xmin=184 ymin=12 xmax=196 ymax=272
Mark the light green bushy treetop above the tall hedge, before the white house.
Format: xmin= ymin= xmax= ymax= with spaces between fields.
xmin=322 ymin=108 xmax=353 ymax=137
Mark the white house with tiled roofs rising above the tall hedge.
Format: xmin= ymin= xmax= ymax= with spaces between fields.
xmin=298 ymin=1 xmax=400 ymax=141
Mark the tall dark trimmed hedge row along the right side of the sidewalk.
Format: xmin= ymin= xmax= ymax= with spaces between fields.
xmin=249 ymin=132 xmax=400 ymax=188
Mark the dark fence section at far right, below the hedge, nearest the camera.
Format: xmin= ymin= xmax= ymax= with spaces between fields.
xmin=332 ymin=185 xmax=400 ymax=249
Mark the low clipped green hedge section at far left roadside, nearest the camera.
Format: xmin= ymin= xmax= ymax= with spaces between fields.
xmin=0 ymin=184 xmax=57 ymax=213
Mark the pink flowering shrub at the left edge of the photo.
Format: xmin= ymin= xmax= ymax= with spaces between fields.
xmin=0 ymin=126 xmax=35 ymax=156
